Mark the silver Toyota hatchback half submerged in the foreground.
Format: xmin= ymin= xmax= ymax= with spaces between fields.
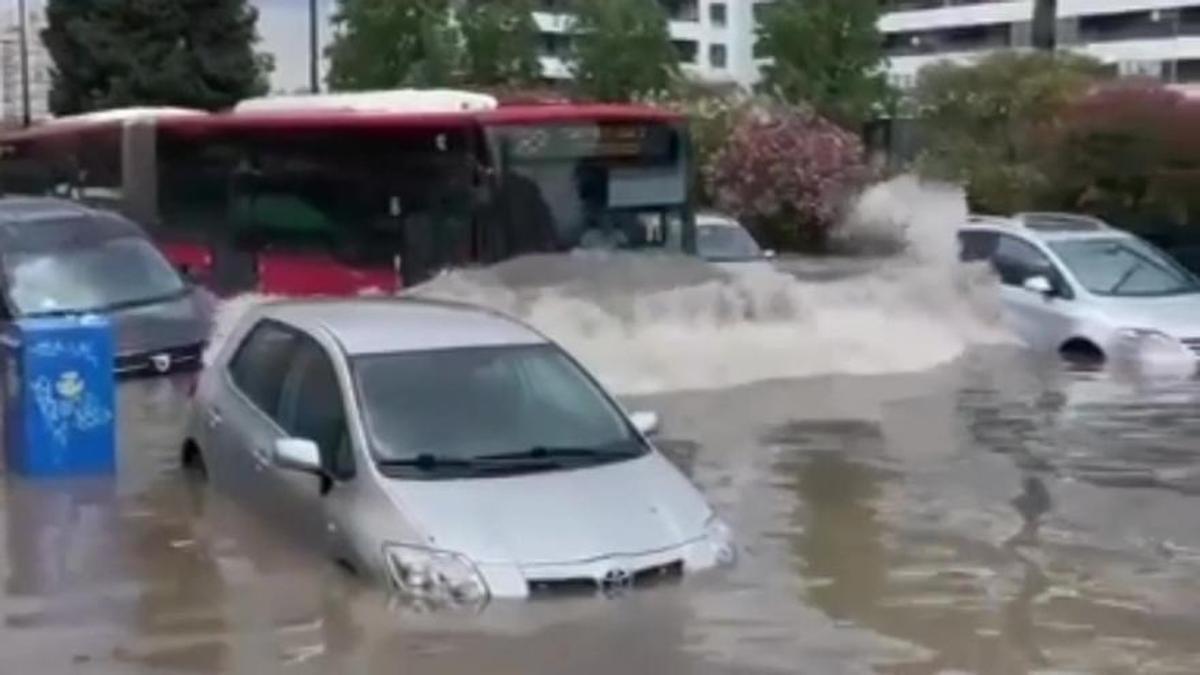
xmin=184 ymin=299 xmax=734 ymax=607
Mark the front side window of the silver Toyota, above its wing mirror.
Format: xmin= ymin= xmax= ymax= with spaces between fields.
xmin=276 ymin=338 xmax=354 ymax=480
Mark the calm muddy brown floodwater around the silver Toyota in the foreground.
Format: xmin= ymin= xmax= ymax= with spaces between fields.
xmin=0 ymin=350 xmax=1200 ymax=675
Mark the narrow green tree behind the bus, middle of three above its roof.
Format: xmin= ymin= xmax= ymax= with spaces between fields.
xmin=458 ymin=0 xmax=541 ymax=86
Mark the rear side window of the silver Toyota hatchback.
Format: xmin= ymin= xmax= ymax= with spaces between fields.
xmin=229 ymin=321 xmax=298 ymax=422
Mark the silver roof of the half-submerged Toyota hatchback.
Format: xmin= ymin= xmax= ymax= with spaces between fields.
xmin=260 ymin=298 xmax=548 ymax=356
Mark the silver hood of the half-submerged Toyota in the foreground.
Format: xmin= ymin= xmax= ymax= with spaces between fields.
xmin=386 ymin=453 xmax=712 ymax=566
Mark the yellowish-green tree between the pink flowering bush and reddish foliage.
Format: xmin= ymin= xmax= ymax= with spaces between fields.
xmin=913 ymin=52 xmax=1104 ymax=214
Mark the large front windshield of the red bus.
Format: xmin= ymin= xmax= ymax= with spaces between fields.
xmin=487 ymin=123 xmax=689 ymax=255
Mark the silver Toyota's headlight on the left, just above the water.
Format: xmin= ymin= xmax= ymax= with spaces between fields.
xmin=383 ymin=544 xmax=491 ymax=608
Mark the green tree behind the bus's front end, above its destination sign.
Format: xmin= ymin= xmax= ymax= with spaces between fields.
xmin=570 ymin=0 xmax=679 ymax=101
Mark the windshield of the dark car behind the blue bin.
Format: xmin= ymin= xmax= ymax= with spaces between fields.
xmin=4 ymin=235 xmax=186 ymax=316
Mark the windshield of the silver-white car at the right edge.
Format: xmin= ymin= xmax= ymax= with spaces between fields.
xmin=1050 ymin=238 xmax=1200 ymax=297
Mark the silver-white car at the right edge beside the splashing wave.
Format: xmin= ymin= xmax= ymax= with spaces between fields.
xmin=959 ymin=214 xmax=1200 ymax=366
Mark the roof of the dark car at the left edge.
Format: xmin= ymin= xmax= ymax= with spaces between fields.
xmin=0 ymin=197 xmax=146 ymax=251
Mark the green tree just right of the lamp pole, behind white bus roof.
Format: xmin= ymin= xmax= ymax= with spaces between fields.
xmin=328 ymin=0 xmax=463 ymax=90
